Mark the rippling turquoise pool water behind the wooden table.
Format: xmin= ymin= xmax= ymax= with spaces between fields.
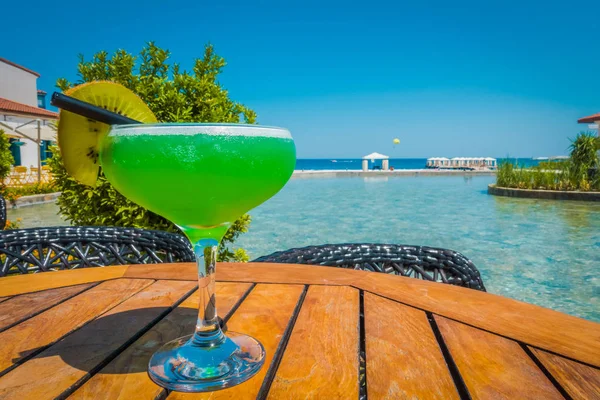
xmin=239 ymin=176 xmax=600 ymax=321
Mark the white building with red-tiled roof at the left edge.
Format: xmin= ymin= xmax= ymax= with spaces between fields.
xmin=0 ymin=58 xmax=58 ymax=167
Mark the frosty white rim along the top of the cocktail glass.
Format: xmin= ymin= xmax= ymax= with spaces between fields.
xmin=110 ymin=123 xmax=292 ymax=139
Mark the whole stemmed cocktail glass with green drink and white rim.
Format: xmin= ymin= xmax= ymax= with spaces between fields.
xmin=100 ymin=124 xmax=296 ymax=392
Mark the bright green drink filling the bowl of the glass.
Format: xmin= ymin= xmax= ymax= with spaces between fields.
xmin=100 ymin=127 xmax=296 ymax=229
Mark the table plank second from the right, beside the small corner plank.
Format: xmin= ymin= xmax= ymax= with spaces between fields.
xmin=434 ymin=315 xmax=563 ymax=399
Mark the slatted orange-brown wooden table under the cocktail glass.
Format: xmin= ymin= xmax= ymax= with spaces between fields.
xmin=0 ymin=263 xmax=600 ymax=400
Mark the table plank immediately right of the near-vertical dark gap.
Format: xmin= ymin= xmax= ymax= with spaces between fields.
xmin=364 ymin=293 xmax=459 ymax=399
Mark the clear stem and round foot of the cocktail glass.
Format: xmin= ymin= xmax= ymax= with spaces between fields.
xmin=148 ymin=230 xmax=265 ymax=392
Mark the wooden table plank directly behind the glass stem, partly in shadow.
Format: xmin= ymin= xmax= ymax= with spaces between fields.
xmin=69 ymin=282 xmax=251 ymax=400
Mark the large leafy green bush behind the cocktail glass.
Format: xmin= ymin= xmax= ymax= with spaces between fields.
xmin=49 ymin=42 xmax=256 ymax=261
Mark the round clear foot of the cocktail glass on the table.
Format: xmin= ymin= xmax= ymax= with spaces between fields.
xmin=148 ymin=330 xmax=265 ymax=392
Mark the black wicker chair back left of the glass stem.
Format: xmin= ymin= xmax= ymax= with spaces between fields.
xmin=0 ymin=226 xmax=195 ymax=277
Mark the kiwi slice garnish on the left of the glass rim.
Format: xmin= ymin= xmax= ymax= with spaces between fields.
xmin=58 ymin=81 xmax=157 ymax=186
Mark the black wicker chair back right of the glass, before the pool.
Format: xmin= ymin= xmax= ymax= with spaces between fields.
xmin=254 ymin=244 xmax=485 ymax=291
